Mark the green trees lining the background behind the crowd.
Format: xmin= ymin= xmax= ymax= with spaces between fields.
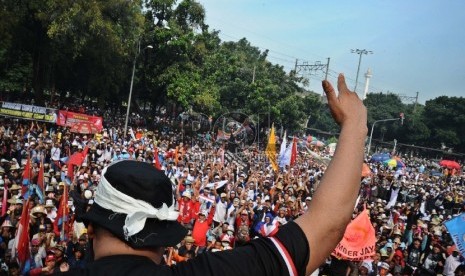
xmin=0 ymin=0 xmax=465 ymax=152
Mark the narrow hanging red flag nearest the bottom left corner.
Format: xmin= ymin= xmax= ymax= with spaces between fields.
xmin=12 ymin=199 xmax=31 ymax=270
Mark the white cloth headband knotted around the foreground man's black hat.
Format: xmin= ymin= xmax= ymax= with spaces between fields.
xmin=94 ymin=167 xmax=179 ymax=240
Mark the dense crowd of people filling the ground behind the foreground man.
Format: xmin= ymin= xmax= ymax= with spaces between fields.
xmin=0 ymin=106 xmax=465 ymax=275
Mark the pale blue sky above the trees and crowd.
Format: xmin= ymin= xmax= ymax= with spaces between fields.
xmin=198 ymin=0 xmax=465 ymax=104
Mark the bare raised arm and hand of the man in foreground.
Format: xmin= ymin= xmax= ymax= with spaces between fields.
xmin=296 ymin=74 xmax=368 ymax=274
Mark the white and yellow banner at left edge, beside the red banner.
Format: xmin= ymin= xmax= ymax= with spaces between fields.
xmin=0 ymin=102 xmax=57 ymax=123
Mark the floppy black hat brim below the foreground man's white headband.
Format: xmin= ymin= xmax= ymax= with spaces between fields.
xmin=82 ymin=202 xmax=187 ymax=248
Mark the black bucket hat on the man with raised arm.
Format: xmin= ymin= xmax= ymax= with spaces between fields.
xmin=82 ymin=160 xmax=187 ymax=248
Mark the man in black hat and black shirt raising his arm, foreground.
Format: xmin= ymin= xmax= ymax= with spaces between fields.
xmin=62 ymin=75 xmax=367 ymax=276
